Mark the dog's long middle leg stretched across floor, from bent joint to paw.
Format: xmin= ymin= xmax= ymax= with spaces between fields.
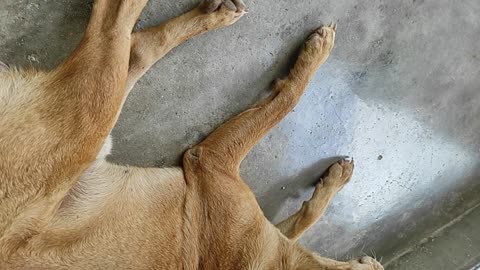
xmin=184 ymin=24 xmax=335 ymax=177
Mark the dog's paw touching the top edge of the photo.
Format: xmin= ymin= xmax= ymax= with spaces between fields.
xmin=199 ymin=0 xmax=248 ymax=27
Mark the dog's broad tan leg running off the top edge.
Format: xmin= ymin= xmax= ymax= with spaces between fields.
xmin=30 ymin=0 xmax=152 ymax=193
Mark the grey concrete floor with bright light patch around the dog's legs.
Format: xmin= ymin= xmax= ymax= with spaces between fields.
xmin=0 ymin=0 xmax=480 ymax=269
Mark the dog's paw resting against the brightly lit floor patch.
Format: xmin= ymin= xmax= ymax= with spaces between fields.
xmin=319 ymin=159 xmax=354 ymax=190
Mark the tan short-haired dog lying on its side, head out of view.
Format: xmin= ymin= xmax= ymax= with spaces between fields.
xmin=0 ymin=0 xmax=383 ymax=270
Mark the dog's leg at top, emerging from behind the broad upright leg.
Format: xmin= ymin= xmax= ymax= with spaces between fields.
xmin=127 ymin=0 xmax=246 ymax=90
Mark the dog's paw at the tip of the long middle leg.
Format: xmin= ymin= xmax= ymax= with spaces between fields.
xmin=302 ymin=23 xmax=337 ymax=63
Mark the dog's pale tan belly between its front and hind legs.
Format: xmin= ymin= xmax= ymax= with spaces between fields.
xmin=14 ymin=161 xmax=185 ymax=269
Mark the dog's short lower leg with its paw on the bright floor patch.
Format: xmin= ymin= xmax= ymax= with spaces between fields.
xmin=276 ymin=160 xmax=353 ymax=240
